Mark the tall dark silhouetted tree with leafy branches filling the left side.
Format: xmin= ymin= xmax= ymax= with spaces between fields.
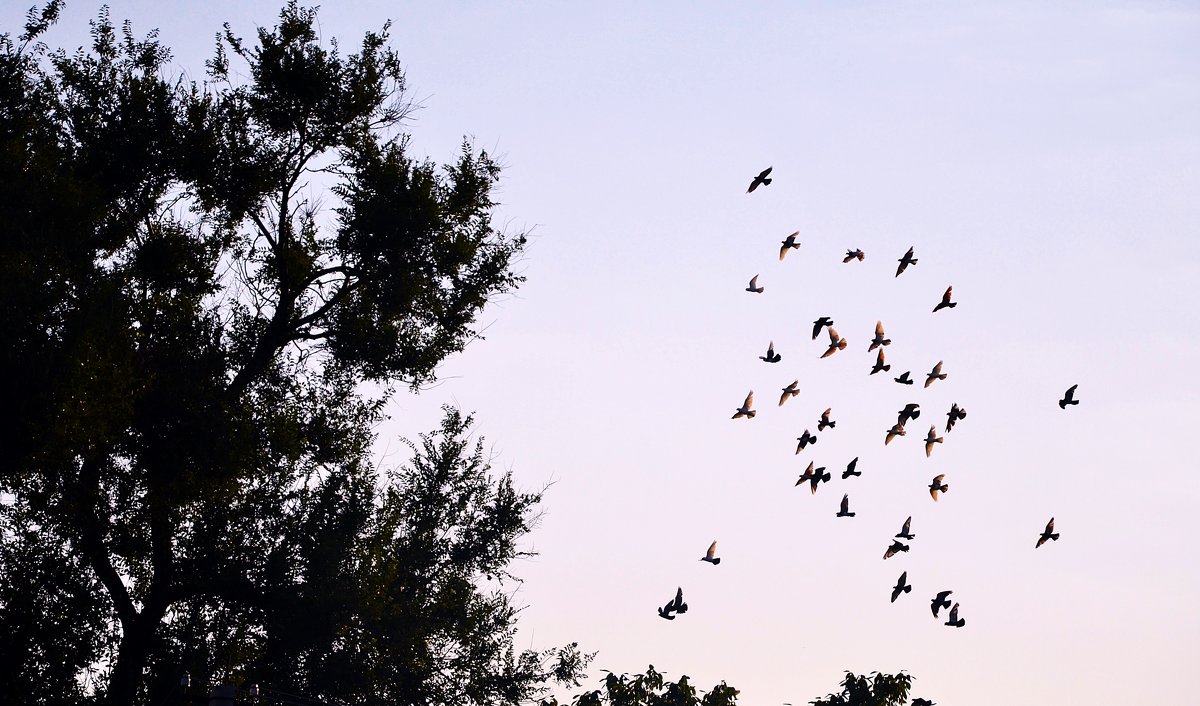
xmin=0 ymin=0 xmax=584 ymax=704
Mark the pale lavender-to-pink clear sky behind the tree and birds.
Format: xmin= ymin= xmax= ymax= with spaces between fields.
xmin=0 ymin=0 xmax=1200 ymax=706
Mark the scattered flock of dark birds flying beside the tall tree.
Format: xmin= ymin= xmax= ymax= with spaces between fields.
xmin=658 ymin=167 xmax=1079 ymax=643
